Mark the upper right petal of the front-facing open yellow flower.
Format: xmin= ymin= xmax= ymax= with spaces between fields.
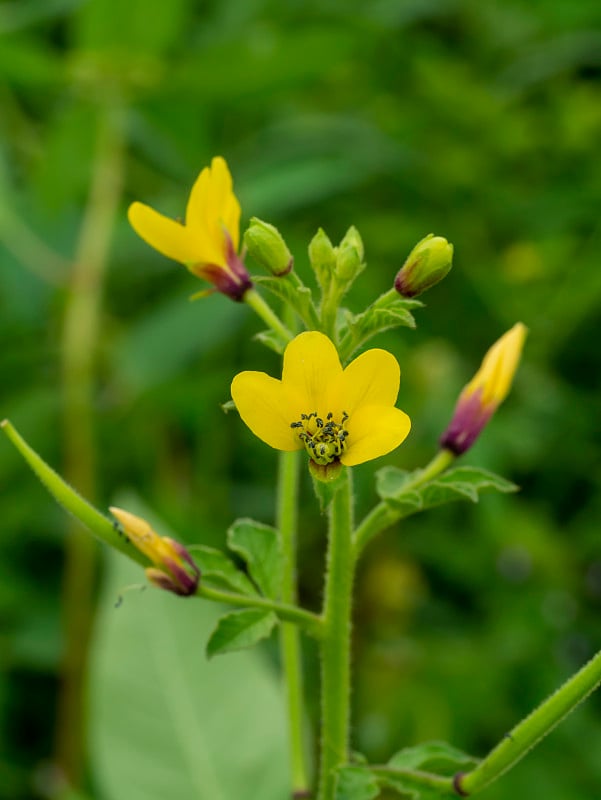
xmin=330 ymin=349 xmax=401 ymax=416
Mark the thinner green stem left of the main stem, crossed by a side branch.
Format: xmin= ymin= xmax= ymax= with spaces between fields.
xmin=277 ymin=451 xmax=309 ymax=795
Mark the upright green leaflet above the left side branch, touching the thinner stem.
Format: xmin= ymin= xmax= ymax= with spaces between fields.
xmin=227 ymin=519 xmax=284 ymax=600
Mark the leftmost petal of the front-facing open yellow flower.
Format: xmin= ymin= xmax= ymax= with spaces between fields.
xmin=232 ymin=372 xmax=303 ymax=450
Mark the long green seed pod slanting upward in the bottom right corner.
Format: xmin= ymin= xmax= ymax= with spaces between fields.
xmin=455 ymin=653 xmax=601 ymax=797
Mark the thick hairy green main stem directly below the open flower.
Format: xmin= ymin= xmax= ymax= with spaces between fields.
xmin=318 ymin=469 xmax=353 ymax=800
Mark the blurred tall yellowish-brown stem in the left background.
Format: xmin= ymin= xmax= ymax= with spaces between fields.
xmin=56 ymin=101 xmax=123 ymax=786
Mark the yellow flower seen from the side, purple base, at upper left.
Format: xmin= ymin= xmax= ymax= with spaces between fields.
xmin=127 ymin=156 xmax=252 ymax=300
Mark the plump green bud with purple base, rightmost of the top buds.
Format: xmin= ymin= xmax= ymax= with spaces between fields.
xmin=394 ymin=233 xmax=453 ymax=297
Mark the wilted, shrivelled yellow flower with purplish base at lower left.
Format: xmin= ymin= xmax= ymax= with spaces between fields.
xmin=110 ymin=507 xmax=200 ymax=596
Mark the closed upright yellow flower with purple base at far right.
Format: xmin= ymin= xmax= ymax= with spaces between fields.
xmin=440 ymin=322 xmax=528 ymax=455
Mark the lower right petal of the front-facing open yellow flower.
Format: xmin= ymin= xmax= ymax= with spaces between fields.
xmin=340 ymin=405 xmax=411 ymax=467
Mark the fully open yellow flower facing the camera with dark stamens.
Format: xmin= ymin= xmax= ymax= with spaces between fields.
xmin=232 ymin=331 xmax=411 ymax=467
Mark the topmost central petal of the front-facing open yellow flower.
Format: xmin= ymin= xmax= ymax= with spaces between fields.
xmin=282 ymin=331 xmax=342 ymax=412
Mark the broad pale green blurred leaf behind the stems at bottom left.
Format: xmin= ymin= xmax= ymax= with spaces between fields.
xmin=89 ymin=552 xmax=289 ymax=800
